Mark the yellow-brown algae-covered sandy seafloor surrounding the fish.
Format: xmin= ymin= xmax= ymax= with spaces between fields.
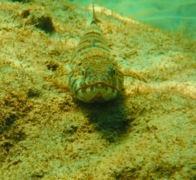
xmin=0 ymin=0 xmax=196 ymax=180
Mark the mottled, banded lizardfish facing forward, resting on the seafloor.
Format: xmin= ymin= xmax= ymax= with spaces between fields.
xmin=68 ymin=7 xmax=123 ymax=103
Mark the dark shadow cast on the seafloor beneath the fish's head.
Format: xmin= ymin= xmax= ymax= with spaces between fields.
xmin=77 ymin=98 xmax=134 ymax=142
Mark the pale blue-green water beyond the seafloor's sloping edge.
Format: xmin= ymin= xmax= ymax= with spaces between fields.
xmin=71 ymin=0 xmax=196 ymax=40
